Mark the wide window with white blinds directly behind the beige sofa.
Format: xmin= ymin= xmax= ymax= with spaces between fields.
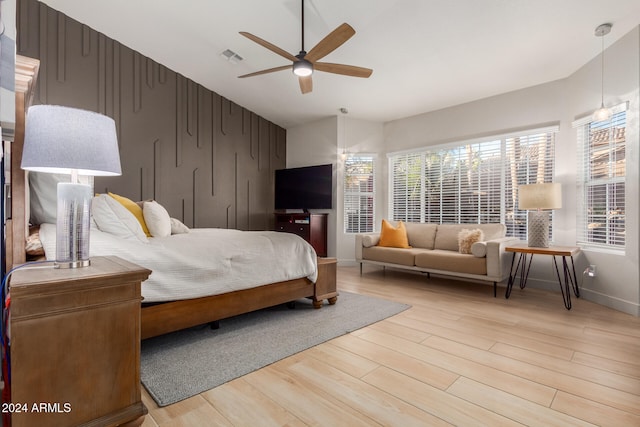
xmin=389 ymin=126 xmax=558 ymax=239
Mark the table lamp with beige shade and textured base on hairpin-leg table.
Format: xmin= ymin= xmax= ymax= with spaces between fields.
xmin=518 ymin=183 xmax=562 ymax=248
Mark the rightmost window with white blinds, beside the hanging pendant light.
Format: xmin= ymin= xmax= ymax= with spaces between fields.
xmin=574 ymin=103 xmax=627 ymax=249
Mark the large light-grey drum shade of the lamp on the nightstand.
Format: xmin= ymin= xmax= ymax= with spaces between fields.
xmin=21 ymin=105 xmax=122 ymax=176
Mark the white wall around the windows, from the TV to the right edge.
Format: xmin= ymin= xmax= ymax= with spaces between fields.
xmin=287 ymin=27 xmax=640 ymax=316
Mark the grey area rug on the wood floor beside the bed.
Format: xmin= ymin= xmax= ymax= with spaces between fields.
xmin=140 ymin=292 xmax=410 ymax=406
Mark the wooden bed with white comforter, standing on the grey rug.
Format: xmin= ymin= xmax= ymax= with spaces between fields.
xmin=6 ymin=57 xmax=337 ymax=339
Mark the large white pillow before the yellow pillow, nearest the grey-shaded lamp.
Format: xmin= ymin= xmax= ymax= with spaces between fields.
xmin=91 ymin=194 xmax=149 ymax=243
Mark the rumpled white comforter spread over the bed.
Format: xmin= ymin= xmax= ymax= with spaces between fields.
xmin=40 ymin=224 xmax=317 ymax=302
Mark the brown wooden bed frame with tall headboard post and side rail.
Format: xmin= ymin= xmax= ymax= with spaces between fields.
xmin=5 ymin=56 xmax=337 ymax=339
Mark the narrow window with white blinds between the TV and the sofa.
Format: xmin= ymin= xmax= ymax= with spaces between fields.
xmin=344 ymin=154 xmax=375 ymax=233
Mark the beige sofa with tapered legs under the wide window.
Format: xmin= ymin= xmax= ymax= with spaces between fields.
xmin=356 ymin=223 xmax=518 ymax=296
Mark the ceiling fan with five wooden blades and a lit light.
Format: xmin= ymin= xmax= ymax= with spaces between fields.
xmin=238 ymin=0 xmax=373 ymax=94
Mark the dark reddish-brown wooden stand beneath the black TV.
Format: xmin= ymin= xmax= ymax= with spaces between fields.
xmin=275 ymin=212 xmax=327 ymax=257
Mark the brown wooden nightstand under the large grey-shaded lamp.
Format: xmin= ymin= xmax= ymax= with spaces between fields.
xmin=10 ymin=257 xmax=151 ymax=427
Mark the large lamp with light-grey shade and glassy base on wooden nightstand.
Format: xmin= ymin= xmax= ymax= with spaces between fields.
xmin=21 ymin=105 xmax=122 ymax=268
